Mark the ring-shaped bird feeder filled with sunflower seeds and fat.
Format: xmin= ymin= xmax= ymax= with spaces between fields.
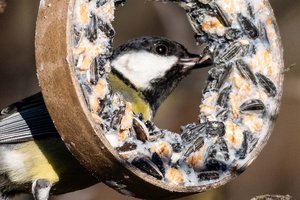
xmin=36 ymin=0 xmax=284 ymax=199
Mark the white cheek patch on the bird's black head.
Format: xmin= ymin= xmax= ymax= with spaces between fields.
xmin=112 ymin=51 xmax=178 ymax=89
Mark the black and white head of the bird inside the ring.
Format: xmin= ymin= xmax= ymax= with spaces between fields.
xmin=111 ymin=36 xmax=210 ymax=111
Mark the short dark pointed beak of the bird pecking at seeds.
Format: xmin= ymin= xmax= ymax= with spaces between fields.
xmin=178 ymin=54 xmax=213 ymax=70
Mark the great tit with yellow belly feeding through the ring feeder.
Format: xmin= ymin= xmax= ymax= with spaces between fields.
xmin=0 ymin=37 xmax=211 ymax=200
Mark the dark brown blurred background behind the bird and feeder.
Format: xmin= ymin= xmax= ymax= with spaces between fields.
xmin=0 ymin=0 xmax=300 ymax=200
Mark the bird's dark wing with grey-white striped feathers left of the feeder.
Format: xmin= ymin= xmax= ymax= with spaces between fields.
xmin=0 ymin=93 xmax=59 ymax=144
